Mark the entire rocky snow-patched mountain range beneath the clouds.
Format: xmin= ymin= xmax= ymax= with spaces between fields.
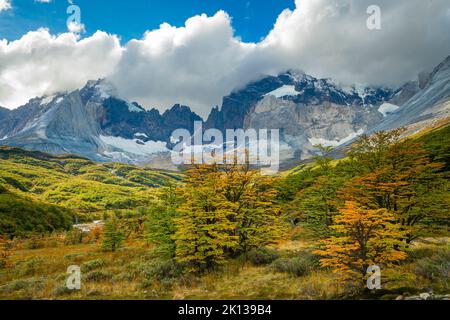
xmin=0 ymin=57 xmax=450 ymax=169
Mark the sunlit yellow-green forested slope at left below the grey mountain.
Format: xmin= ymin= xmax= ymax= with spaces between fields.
xmin=0 ymin=147 xmax=181 ymax=219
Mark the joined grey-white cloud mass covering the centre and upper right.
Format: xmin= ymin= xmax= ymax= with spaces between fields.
xmin=112 ymin=0 xmax=450 ymax=116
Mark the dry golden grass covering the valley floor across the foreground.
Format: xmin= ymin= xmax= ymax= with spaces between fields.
xmin=0 ymin=238 xmax=450 ymax=300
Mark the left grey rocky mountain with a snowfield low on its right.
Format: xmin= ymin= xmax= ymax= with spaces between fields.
xmin=0 ymin=80 xmax=201 ymax=168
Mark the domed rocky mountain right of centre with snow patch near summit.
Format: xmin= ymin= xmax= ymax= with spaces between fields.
xmin=206 ymin=71 xmax=394 ymax=161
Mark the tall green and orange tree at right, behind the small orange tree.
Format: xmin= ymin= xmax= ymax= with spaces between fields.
xmin=340 ymin=129 xmax=450 ymax=243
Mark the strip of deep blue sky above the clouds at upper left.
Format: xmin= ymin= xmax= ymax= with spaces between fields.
xmin=0 ymin=0 xmax=295 ymax=42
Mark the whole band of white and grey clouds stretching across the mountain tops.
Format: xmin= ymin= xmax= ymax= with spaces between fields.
xmin=0 ymin=0 xmax=450 ymax=116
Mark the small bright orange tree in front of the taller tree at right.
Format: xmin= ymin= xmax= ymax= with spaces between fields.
xmin=315 ymin=201 xmax=406 ymax=290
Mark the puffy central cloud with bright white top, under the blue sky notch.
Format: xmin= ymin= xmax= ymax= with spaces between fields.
xmin=110 ymin=11 xmax=265 ymax=119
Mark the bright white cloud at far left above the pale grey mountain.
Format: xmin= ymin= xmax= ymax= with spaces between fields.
xmin=0 ymin=29 xmax=122 ymax=108
